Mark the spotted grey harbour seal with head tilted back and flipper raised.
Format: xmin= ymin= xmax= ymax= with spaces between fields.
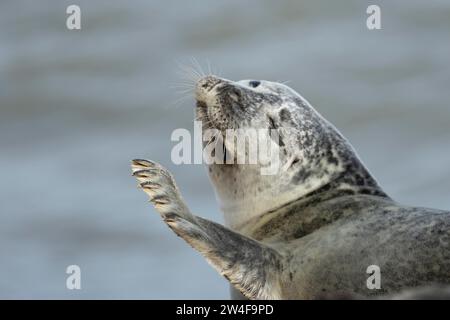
xmin=132 ymin=76 xmax=450 ymax=299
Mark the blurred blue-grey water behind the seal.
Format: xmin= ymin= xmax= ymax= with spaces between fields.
xmin=0 ymin=0 xmax=450 ymax=299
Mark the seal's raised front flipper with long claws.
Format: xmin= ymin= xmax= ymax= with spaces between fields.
xmin=132 ymin=160 xmax=283 ymax=299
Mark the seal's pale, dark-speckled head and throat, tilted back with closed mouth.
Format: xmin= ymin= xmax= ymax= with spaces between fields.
xmin=195 ymin=76 xmax=387 ymax=229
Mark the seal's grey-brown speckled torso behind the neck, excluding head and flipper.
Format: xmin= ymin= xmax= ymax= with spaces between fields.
xmin=248 ymin=195 xmax=450 ymax=299
